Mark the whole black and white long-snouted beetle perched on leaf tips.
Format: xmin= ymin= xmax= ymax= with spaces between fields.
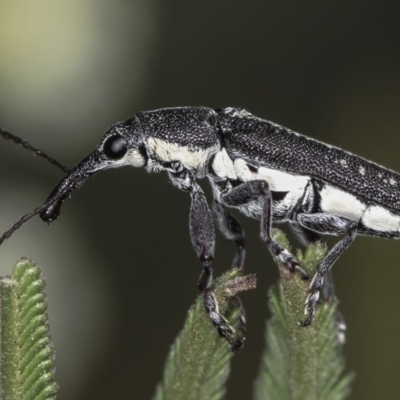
xmin=0 ymin=107 xmax=400 ymax=349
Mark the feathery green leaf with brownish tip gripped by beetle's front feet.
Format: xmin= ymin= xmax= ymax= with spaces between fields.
xmin=154 ymin=270 xmax=255 ymax=400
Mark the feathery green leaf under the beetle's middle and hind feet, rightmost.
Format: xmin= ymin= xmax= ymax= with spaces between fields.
xmin=254 ymin=230 xmax=352 ymax=400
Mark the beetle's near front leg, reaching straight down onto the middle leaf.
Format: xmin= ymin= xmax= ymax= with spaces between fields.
xmin=189 ymin=180 xmax=244 ymax=350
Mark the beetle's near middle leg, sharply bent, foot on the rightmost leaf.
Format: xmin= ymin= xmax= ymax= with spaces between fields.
xmin=221 ymin=180 xmax=308 ymax=279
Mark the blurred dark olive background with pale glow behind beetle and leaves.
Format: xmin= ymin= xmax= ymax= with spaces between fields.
xmin=0 ymin=0 xmax=400 ymax=400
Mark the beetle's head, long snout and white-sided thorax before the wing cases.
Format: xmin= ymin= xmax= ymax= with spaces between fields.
xmin=40 ymin=107 xmax=219 ymax=223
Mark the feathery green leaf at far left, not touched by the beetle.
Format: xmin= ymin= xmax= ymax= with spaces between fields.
xmin=0 ymin=258 xmax=58 ymax=400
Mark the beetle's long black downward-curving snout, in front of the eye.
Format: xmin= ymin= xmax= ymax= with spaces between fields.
xmin=40 ymin=152 xmax=105 ymax=223
